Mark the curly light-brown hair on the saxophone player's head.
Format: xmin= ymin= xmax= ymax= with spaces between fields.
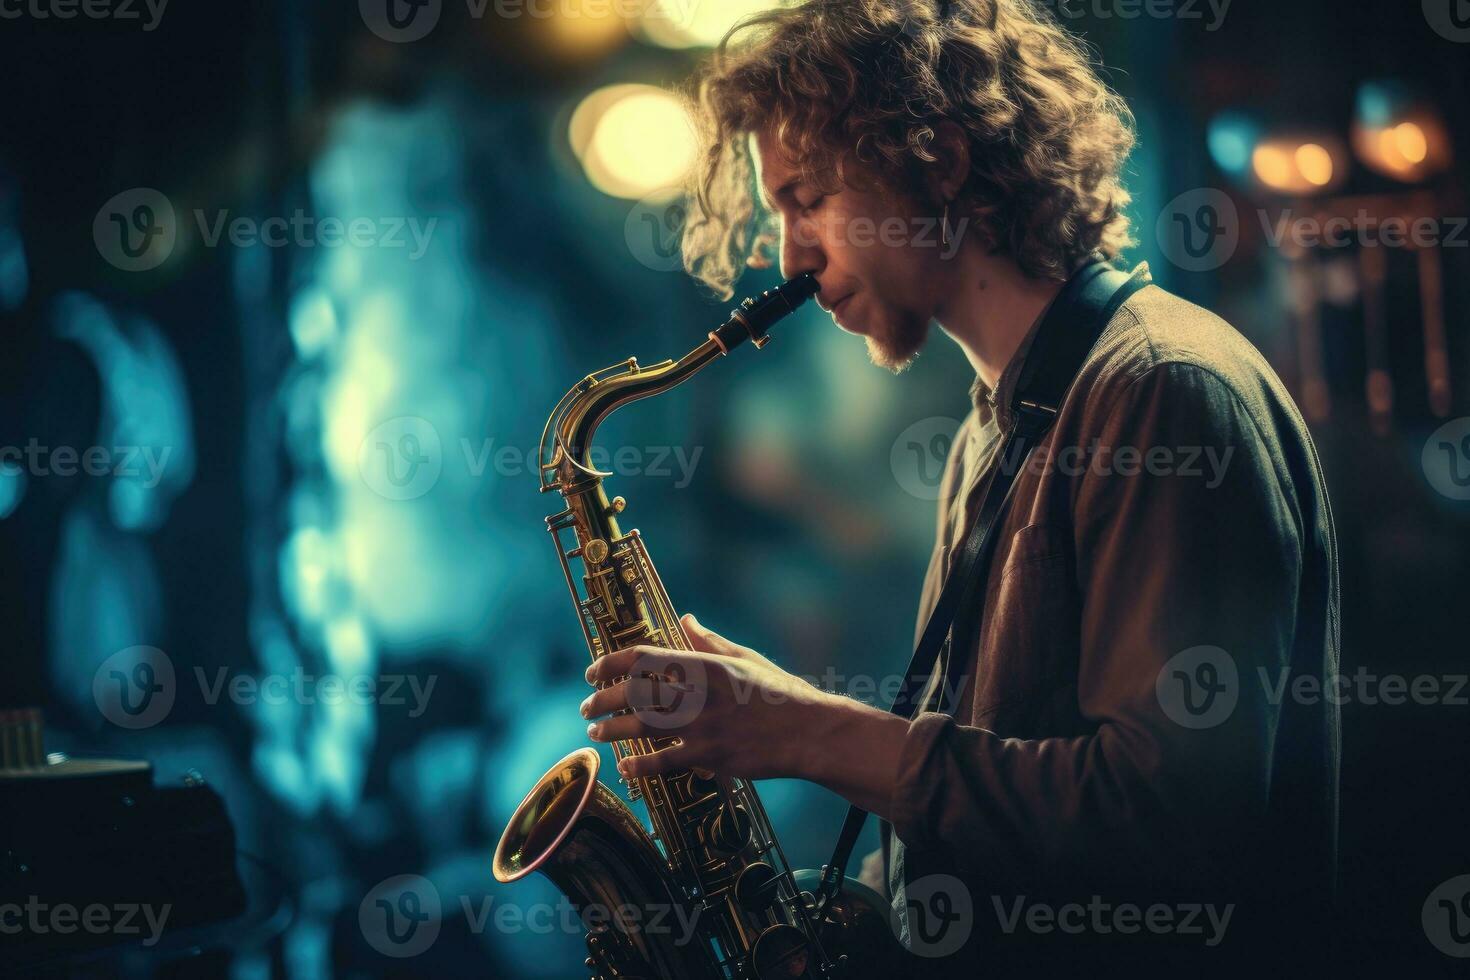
xmin=682 ymin=0 xmax=1133 ymax=300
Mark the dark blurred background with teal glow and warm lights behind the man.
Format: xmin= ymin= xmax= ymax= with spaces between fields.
xmin=0 ymin=0 xmax=1470 ymax=979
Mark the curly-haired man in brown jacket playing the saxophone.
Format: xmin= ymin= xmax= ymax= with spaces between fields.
xmin=582 ymin=0 xmax=1339 ymax=976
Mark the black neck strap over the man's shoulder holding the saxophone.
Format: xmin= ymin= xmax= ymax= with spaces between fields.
xmin=819 ymin=262 xmax=1148 ymax=912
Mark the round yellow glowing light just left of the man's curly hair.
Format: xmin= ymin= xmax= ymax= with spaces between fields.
xmin=569 ymin=85 xmax=694 ymax=198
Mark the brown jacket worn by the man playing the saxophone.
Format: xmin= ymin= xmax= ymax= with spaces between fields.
xmin=883 ymin=266 xmax=1339 ymax=969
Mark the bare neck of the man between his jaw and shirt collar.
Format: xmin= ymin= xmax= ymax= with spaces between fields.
xmin=935 ymin=249 xmax=1063 ymax=388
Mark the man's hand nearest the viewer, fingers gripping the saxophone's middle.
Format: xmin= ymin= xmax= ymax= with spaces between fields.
xmin=582 ymin=616 xmax=836 ymax=779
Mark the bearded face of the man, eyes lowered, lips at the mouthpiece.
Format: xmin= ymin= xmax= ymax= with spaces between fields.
xmin=751 ymin=131 xmax=954 ymax=373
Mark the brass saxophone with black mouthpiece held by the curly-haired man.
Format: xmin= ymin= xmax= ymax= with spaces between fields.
xmin=494 ymin=273 xmax=897 ymax=980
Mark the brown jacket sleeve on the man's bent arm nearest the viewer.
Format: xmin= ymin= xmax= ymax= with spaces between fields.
xmin=891 ymin=363 xmax=1301 ymax=880
